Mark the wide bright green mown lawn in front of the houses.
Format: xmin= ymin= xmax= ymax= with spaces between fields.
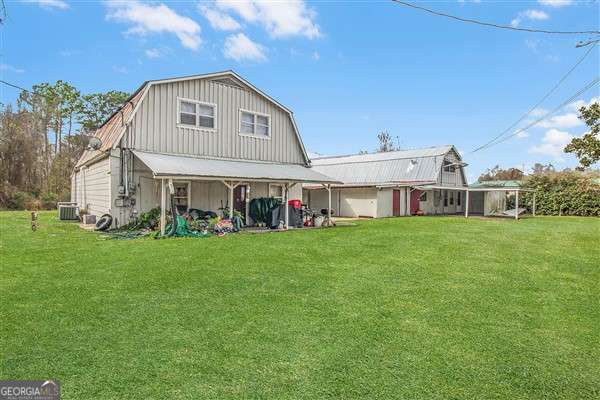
xmin=0 ymin=212 xmax=600 ymax=399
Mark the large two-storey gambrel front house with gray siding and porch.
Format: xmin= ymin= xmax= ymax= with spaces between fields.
xmin=71 ymin=71 xmax=337 ymax=229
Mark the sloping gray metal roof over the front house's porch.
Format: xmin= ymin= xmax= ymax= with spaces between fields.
xmin=133 ymin=150 xmax=341 ymax=184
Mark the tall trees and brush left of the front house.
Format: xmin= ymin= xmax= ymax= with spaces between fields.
xmin=0 ymin=80 xmax=129 ymax=209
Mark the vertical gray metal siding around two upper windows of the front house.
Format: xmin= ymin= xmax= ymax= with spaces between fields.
xmin=128 ymin=79 xmax=305 ymax=164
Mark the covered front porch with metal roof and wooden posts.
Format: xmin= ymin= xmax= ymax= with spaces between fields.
xmin=134 ymin=151 xmax=337 ymax=234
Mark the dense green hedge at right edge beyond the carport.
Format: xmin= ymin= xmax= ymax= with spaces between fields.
xmin=524 ymin=171 xmax=600 ymax=217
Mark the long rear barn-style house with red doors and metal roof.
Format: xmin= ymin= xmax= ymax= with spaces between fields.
xmin=303 ymin=145 xmax=467 ymax=218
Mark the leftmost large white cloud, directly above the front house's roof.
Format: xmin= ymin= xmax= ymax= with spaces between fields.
xmin=106 ymin=0 xmax=202 ymax=50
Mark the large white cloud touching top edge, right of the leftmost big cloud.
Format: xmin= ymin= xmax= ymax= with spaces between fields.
xmin=216 ymin=0 xmax=321 ymax=39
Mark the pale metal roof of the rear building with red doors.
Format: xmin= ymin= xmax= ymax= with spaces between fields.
xmin=312 ymin=145 xmax=458 ymax=186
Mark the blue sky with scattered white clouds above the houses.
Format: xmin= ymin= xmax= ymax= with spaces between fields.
xmin=0 ymin=0 xmax=600 ymax=181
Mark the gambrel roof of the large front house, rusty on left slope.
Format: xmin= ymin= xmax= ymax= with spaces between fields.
xmin=75 ymin=70 xmax=310 ymax=169
